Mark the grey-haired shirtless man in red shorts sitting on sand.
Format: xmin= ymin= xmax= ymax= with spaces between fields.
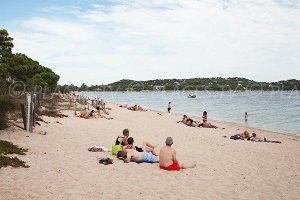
xmin=159 ymin=137 xmax=196 ymax=171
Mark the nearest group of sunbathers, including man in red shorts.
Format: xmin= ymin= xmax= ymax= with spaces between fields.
xmin=115 ymin=129 xmax=196 ymax=171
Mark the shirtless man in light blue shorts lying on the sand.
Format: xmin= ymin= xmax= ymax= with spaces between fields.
xmin=117 ymin=149 xmax=159 ymax=163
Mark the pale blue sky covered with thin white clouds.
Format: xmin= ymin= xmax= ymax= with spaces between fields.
xmin=0 ymin=0 xmax=300 ymax=86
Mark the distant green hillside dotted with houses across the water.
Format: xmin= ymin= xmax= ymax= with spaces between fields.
xmin=61 ymin=77 xmax=300 ymax=91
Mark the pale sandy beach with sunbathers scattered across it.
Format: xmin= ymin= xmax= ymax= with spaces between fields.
xmin=0 ymin=103 xmax=300 ymax=200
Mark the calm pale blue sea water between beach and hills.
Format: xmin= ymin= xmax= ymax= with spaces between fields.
xmin=81 ymin=91 xmax=300 ymax=135
